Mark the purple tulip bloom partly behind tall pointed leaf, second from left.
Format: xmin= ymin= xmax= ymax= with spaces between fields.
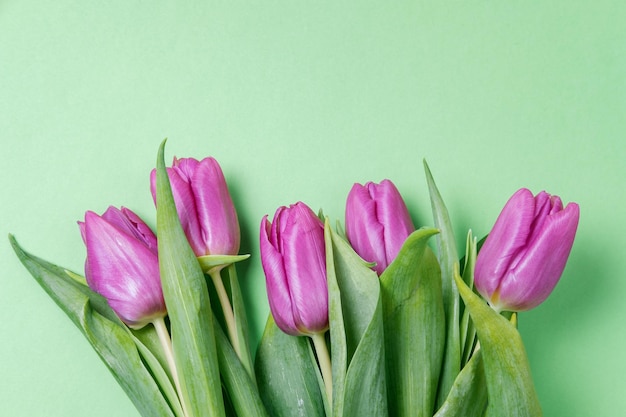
xmin=150 ymin=158 xmax=240 ymax=256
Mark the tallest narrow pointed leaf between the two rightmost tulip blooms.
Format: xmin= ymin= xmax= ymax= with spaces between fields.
xmin=424 ymin=160 xmax=461 ymax=405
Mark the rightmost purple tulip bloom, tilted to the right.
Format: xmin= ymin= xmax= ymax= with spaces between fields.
xmin=474 ymin=188 xmax=579 ymax=311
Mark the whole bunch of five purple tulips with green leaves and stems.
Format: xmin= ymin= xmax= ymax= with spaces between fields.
xmin=10 ymin=141 xmax=579 ymax=417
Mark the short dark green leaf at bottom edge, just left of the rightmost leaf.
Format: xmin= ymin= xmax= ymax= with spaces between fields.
xmin=434 ymin=350 xmax=487 ymax=417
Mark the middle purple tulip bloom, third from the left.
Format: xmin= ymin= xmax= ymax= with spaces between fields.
xmin=261 ymin=202 xmax=328 ymax=335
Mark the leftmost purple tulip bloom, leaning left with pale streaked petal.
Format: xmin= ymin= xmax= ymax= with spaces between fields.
xmin=78 ymin=207 xmax=167 ymax=329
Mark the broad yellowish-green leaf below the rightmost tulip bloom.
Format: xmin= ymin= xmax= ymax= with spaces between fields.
xmin=455 ymin=274 xmax=542 ymax=417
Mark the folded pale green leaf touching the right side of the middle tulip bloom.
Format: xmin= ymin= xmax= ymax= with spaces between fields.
xmin=325 ymin=221 xmax=388 ymax=417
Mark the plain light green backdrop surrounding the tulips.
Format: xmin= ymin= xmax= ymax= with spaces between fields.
xmin=0 ymin=0 xmax=626 ymax=417
